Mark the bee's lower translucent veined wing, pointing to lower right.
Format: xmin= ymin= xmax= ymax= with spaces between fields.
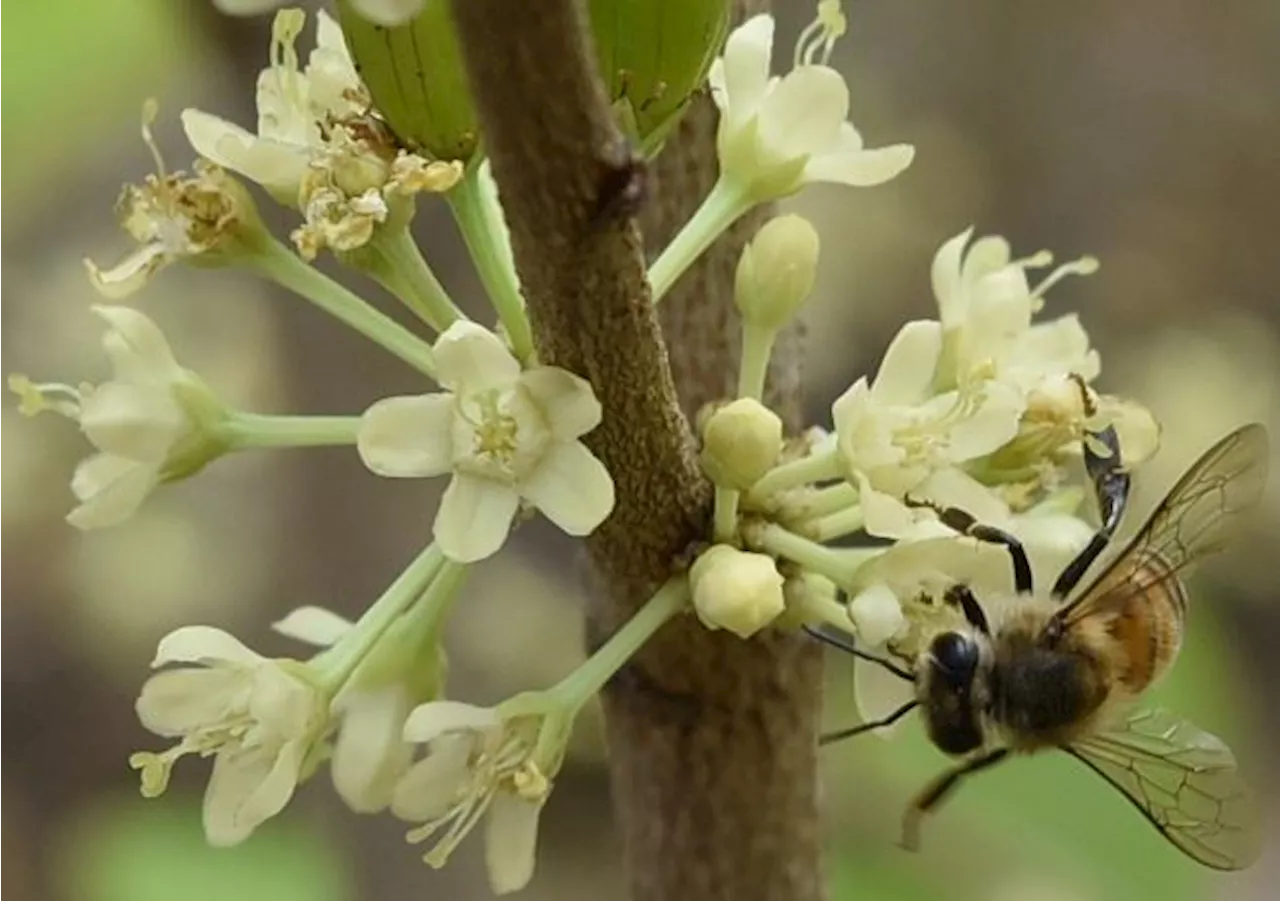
xmin=1066 ymin=710 xmax=1262 ymax=870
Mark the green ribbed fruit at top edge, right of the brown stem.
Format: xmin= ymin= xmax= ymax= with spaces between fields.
xmin=590 ymin=0 xmax=728 ymax=156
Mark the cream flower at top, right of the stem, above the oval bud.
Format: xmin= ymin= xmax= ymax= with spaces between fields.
xmin=708 ymin=14 xmax=914 ymax=201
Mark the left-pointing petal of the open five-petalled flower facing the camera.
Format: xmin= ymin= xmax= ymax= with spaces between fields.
xmin=356 ymin=393 xmax=456 ymax=479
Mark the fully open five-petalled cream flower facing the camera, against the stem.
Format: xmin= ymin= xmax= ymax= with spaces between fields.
xmin=357 ymin=321 xmax=613 ymax=563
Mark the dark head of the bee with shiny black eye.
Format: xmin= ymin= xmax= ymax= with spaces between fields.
xmin=916 ymin=631 xmax=988 ymax=754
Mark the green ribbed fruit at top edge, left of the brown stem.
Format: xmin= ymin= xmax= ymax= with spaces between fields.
xmin=338 ymin=0 xmax=480 ymax=163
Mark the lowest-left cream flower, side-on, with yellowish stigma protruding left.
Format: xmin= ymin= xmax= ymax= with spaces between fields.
xmin=129 ymin=626 xmax=329 ymax=846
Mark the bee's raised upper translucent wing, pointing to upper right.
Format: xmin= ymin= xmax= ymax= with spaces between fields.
xmin=1057 ymin=422 xmax=1268 ymax=622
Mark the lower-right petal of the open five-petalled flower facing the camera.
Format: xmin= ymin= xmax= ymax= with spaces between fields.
xmin=520 ymin=442 xmax=614 ymax=535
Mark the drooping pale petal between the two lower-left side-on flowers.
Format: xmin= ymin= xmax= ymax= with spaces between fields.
xmin=329 ymin=685 xmax=413 ymax=814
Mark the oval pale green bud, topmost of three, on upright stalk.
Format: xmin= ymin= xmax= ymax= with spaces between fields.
xmin=733 ymin=214 xmax=818 ymax=331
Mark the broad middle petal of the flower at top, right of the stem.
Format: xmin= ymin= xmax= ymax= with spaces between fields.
xmin=759 ymin=65 xmax=849 ymax=164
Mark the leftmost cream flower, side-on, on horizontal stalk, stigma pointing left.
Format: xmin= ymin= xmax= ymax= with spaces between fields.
xmin=9 ymin=306 xmax=228 ymax=529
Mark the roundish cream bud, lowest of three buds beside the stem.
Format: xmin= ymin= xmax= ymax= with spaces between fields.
xmin=689 ymin=544 xmax=786 ymax=639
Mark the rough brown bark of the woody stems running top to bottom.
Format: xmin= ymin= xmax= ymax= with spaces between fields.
xmin=453 ymin=0 xmax=822 ymax=901
